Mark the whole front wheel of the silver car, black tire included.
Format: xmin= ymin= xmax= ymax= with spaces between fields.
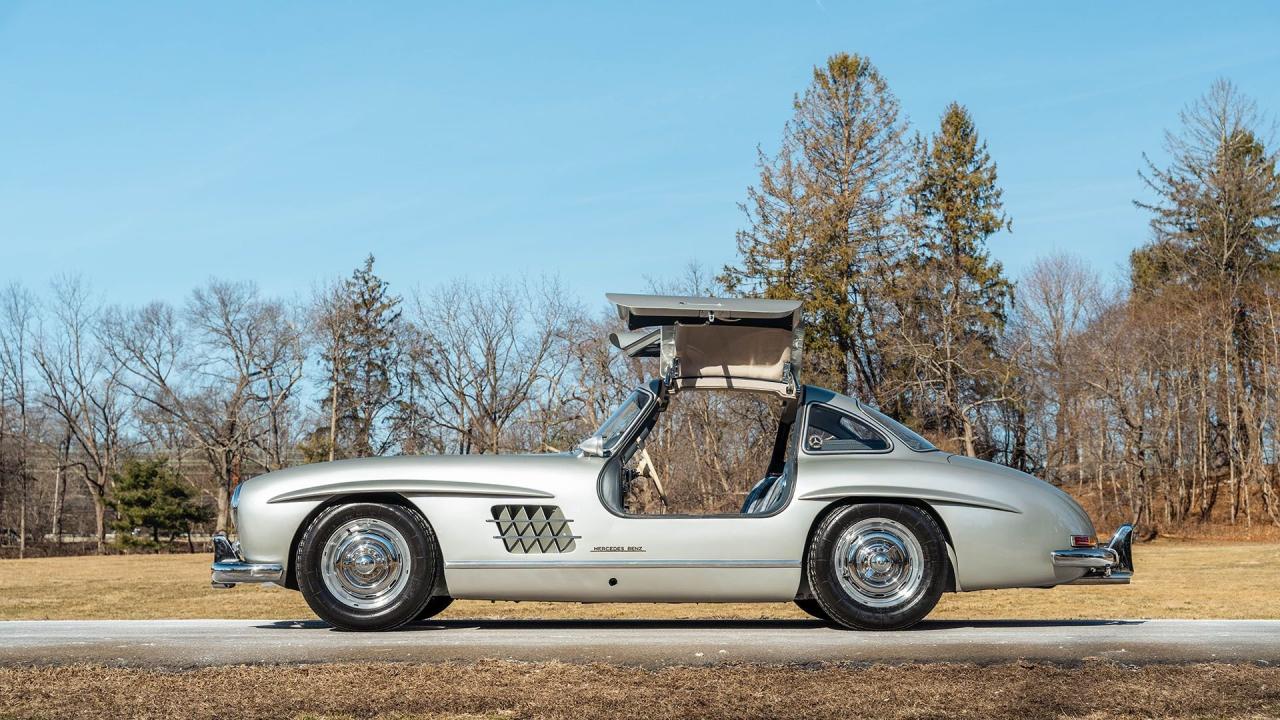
xmin=294 ymin=502 xmax=439 ymax=632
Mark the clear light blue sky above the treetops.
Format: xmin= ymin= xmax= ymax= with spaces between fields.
xmin=0 ymin=0 xmax=1280 ymax=304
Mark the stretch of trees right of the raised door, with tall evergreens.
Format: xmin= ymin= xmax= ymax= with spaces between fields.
xmin=721 ymin=55 xmax=1280 ymax=529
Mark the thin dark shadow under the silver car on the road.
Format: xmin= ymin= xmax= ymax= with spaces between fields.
xmin=255 ymin=618 xmax=1144 ymax=633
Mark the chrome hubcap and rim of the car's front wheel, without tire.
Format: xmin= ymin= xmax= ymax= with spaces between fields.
xmin=320 ymin=518 xmax=412 ymax=610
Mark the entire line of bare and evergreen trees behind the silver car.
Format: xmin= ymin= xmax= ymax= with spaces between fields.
xmin=0 ymin=54 xmax=1280 ymax=553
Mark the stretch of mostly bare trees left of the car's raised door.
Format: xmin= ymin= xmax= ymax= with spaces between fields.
xmin=0 ymin=256 xmax=624 ymax=551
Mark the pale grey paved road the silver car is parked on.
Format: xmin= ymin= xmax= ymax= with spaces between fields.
xmin=0 ymin=620 xmax=1280 ymax=667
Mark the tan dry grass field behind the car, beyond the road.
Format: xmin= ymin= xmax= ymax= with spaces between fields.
xmin=0 ymin=541 xmax=1280 ymax=620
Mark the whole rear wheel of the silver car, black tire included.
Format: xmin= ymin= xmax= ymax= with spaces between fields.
xmin=805 ymin=502 xmax=948 ymax=630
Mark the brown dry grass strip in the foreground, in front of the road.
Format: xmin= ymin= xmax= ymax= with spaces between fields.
xmin=0 ymin=661 xmax=1280 ymax=720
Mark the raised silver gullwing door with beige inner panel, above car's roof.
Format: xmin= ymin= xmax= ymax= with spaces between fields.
xmin=605 ymin=292 xmax=801 ymax=397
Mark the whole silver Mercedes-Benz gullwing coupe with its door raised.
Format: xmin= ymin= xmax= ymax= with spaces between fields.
xmin=212 ymin=295 xmax=1133 ymax=630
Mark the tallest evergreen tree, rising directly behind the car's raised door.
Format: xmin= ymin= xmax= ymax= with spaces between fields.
xmin=721 ymin=53 xmax=905 ymax=395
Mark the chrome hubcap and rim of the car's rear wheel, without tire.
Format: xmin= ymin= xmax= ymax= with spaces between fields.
xmin=832 ymin=518 xmax=924 ymax=607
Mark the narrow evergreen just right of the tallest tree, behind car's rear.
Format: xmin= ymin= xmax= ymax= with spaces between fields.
xmin=886 ymin=102 xmax=1012 ymax=455
